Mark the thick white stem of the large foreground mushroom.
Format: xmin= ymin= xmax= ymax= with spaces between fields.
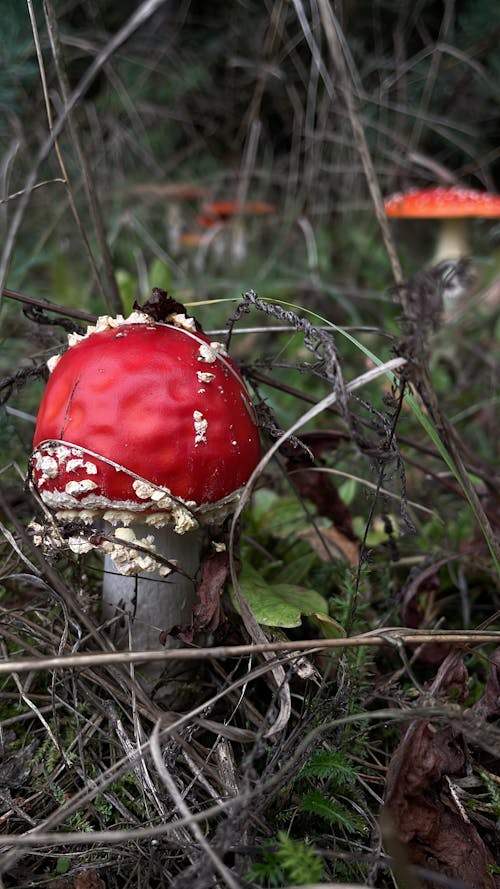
xmin=103 ymin=525 xmax=203 ymax=651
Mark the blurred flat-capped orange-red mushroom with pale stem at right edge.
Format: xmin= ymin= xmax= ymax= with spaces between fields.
xmin=384 ymin=186 xmax=500 ymax=265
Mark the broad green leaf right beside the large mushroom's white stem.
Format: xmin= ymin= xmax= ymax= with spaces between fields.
xmin=231 ymin=565 xmax=328 ymax=627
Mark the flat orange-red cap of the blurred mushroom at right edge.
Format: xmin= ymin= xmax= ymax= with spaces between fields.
xmin=384 ymin=186 xmax=500 ymax=219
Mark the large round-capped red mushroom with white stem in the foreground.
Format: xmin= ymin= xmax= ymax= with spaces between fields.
xmin=31 ymin=289 xmax=261 ymax=649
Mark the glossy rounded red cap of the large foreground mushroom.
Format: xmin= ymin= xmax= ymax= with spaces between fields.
xmin=32 ymin=316 xmax=261 ymax=531
